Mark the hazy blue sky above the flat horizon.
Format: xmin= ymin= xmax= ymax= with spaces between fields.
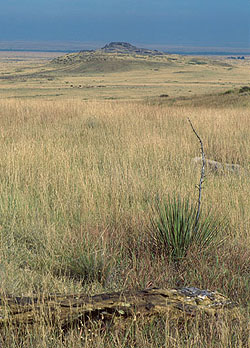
xmin=0 ymin=0 xmax=250 ymax=48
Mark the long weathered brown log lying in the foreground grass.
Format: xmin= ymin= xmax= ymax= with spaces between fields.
xmin=0 ymin=287 xmax=237 ymax=329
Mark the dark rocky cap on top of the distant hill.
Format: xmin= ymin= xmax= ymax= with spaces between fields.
xmin=100 ymin=42 xmax=164 ymax=56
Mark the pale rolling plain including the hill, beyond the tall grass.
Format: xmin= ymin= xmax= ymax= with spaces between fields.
xmin=0 ymin=43 xmax=250 ymax=105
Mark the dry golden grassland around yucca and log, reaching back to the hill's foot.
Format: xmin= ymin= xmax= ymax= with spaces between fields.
xmin=0 ymin=51 xmax=250 ymax=348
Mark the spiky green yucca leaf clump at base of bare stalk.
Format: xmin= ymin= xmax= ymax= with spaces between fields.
xmin=151 ymin=196 xmax=226 ymax=260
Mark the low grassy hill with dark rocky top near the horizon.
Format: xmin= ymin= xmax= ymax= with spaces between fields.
xmin=50 ymin=42 xmax=231 ymax=75
